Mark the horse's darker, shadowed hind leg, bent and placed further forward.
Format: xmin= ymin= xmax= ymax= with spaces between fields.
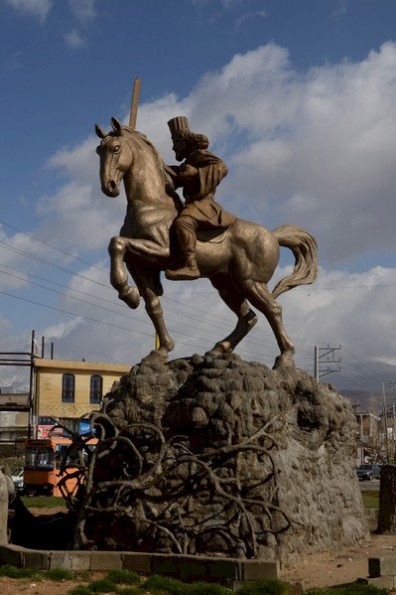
xmin=209 ymin=275 xmax=257 ymax=355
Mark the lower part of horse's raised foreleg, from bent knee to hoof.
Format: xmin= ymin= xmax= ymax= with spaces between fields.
xmin=109 ymin=236 xmax=140 ymax=309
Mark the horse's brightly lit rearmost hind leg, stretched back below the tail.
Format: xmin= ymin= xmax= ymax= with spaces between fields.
xmin=238 ymin=279 xmax=294 ymax=368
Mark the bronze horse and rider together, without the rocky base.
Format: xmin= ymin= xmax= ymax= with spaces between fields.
xmin=96 ymin=116 xmax=318 ymax=367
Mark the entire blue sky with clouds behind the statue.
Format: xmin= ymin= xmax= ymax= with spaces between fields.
xmin=0 ymin=0 xmax=396 ymax=400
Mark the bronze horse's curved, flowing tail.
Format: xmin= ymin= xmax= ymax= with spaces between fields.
xmin=272 ymin=225 xmax=318 ymax=298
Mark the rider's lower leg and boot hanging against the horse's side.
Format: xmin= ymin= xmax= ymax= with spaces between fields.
xmin=165 ymin=215 xmax=201 ymax=281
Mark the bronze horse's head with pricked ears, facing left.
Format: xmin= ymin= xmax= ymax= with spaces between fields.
xmin=95 ymin=118 xmax=133 ymax=197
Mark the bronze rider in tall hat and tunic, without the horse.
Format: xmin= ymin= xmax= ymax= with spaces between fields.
xmin=165 ymin=116 xmax=236 ymax=281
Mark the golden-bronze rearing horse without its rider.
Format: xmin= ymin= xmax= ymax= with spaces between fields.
xmin=96 ymin=118 xmax=317 ymax=366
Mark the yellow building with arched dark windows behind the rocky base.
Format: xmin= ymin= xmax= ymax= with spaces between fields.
xmin=32 ymin=358 xmax=131 ymax=420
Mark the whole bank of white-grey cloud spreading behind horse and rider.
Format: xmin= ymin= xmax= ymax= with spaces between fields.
xmin=7 ymin=43 xmax=396 ymax=386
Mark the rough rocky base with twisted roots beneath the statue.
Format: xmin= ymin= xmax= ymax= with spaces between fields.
xmin=74 ymin=354 xmax=367 ymax=565
